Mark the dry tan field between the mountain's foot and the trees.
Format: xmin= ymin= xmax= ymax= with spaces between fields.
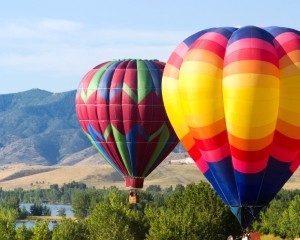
xmin=0 ymin=161 xmax=300 ymax=189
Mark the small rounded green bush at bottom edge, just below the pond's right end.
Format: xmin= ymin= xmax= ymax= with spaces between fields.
xmin=52 ymin=219 xmax=89 ymax=240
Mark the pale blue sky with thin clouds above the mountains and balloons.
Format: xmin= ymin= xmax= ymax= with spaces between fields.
xmin=0 ymin=0 xmax=300 ymax=94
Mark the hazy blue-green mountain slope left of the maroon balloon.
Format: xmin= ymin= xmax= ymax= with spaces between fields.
xmin=0 ymin=89 xmax=184 ymax=165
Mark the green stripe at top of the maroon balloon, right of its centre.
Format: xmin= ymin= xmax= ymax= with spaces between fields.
xmin=137 ymin=60 xmax=152 ymax=103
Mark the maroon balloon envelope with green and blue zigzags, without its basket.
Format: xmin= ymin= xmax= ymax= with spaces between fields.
xmin=76 ymin=59 xmax=178 ymax=201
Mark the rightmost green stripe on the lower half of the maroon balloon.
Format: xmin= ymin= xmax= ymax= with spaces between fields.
xmin=143 ymin=124 xmax=170 ymax=177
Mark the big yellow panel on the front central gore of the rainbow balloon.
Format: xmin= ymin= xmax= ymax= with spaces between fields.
xmin=223 ymin=68 xmax=279 ymax=139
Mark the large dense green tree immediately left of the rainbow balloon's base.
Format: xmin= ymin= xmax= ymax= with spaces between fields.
xmin=145 ymin=182 xmax=240 ymax=240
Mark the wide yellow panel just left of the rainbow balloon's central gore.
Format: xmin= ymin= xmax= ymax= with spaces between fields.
xmin=179 ymin=61 xmax=224 ymax=128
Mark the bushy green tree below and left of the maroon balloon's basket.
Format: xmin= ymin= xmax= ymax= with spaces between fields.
xmin=88 ymin=191 xmax=148 ymax=240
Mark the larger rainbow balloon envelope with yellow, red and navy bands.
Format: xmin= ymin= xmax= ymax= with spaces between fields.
xmin=162 ymin=26 xmax=300 ymax=229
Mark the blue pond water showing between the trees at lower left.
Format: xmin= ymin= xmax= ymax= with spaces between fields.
xmin=16 ymin=203 xmax=74 ymax=230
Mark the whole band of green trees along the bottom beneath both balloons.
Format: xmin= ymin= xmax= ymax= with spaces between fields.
xmin=0 ymin=182 xmax=300 ymax=240
